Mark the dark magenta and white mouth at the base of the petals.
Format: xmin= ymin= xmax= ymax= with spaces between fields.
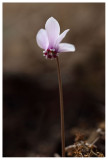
xmin=43 ymin=49 xmax=58 ymax=59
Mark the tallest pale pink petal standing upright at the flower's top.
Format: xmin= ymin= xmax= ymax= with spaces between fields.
xmin=45 ymin=17 xmax=60 ymax=48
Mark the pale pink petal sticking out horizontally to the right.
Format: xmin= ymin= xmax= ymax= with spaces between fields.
xmin=58 ymin=43 xmax=75 ymax=53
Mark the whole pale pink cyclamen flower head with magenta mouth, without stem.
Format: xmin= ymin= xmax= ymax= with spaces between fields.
xmin=36 ymin=17 xmax=75 ymax=59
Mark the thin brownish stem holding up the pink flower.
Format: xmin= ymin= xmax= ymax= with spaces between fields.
xmin=56 ymin=57 xmax=65 ymax=157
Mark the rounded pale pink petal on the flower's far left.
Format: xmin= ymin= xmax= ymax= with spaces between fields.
xmin=36 ymin=29 xmax=49 ymax=50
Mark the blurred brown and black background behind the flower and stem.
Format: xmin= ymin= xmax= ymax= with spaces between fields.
xmin=3 ymin=3 xmax=105 ymax=157
